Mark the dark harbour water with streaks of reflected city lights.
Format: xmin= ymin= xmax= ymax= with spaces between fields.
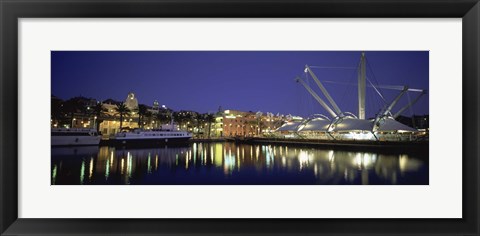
xmin=51 ymin=143 xmax=428 ymax=185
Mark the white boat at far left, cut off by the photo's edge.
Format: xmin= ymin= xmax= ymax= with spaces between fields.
xmin=51 ymin=128 xmax=101 ymax=146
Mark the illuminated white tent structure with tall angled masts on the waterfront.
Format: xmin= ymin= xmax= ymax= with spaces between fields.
xmin=277 ymin=53 xmax=425 ymax=140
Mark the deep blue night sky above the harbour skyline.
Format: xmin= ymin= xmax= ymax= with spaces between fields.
xmin=51 ymin=51 xmax=429 ymax=117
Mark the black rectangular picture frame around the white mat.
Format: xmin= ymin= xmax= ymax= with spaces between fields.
xmin=0 ymin=0 xmax=480 ymax=235
